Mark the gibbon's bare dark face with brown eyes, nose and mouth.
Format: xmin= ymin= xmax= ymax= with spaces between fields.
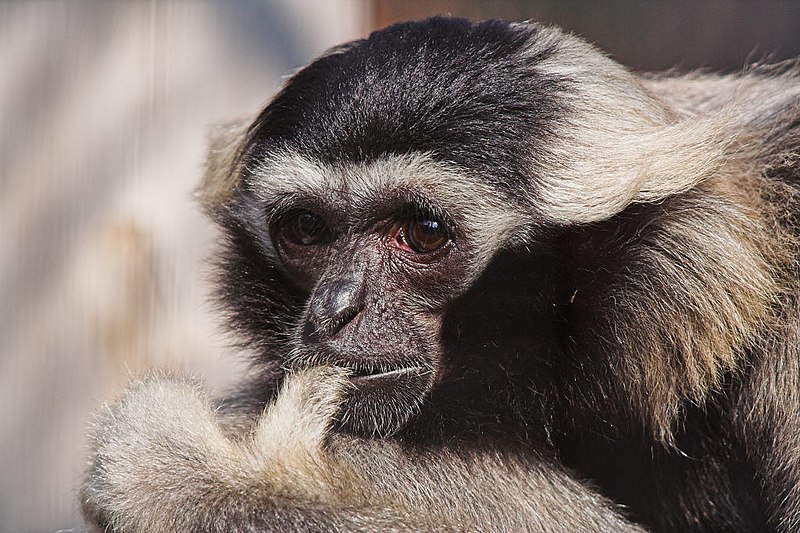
xmin=270 ymin=205 xmax=463 ymax=435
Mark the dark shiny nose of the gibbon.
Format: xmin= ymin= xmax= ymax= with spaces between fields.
xmin=302 ymin=279 xmax=363 ymax=344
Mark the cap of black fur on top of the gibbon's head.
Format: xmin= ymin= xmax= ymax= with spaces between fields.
xmin=241 ymin=18 xmax=567 ymax=198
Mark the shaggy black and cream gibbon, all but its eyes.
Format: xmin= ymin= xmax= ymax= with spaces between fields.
xmin=82 ymin=18 xmax=800 ymax=532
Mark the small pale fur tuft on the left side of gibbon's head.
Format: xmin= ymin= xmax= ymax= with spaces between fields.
xmin=195 ymin=117 xmax=252 ymax=215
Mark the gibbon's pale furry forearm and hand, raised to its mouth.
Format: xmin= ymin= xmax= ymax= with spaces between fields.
xmin=82 ymin=367 xmax=641 ymax=532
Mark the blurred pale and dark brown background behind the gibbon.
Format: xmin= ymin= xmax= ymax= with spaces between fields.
xmin=0 ymin=0 xmax=800 ymax=533
